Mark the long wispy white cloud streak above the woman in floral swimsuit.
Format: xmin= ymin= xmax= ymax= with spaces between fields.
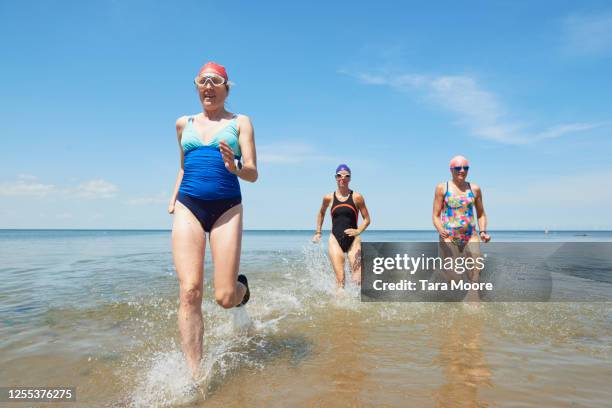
xmin=343 ymin=72 xmax=601 ymax=144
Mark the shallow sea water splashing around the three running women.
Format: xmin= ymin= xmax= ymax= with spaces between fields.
xmin=0 ymin=231 xmax=612 ymax=407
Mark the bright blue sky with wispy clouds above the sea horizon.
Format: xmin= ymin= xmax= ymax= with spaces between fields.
xmin=0 ymin=1 xmax=612 ymax=229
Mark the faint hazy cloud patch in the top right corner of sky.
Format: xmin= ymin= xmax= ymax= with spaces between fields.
xmin=563 ymin=12 xmax=612 ymax=55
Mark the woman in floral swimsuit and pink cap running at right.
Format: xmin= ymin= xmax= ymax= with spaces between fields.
xmin=432 ymin=156 xmax=491 ymax=300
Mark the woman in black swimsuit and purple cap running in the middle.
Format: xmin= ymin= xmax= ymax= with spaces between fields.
xmin=312 ymin=164 xmax=370 ymax=288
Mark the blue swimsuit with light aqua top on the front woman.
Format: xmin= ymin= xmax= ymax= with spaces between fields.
xmin=177 ymin=117 xmax=242 ymax=232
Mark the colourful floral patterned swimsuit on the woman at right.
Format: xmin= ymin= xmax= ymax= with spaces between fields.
xmin=440 ymin=181 xmax=476 ymax=245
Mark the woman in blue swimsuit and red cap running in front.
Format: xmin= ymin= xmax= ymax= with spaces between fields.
xmin=168 ymin=62 xmax=257 ymax=377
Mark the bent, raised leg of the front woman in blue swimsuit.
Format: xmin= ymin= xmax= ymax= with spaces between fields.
xmin=210 ymin=204 xmax=246 ymax=309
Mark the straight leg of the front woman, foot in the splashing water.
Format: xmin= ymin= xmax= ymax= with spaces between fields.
xmin=172 ymin=201 xmax=206 ymax=378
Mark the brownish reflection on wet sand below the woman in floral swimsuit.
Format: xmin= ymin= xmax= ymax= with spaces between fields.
xmin=435 ymin=305 xmax=493 ymax=407
